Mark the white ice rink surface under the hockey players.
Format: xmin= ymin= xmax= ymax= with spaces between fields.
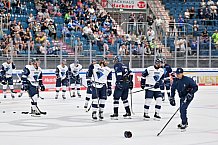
xmin=0 ymin=87 xmax=218 ymax=145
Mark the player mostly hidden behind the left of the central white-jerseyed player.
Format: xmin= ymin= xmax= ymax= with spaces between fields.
xmin=84 ymin=59 xmax=96 ymax=108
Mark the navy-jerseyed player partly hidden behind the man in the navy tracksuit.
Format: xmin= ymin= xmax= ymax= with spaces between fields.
xmin=160 ymin=58 xmax=172 ymax=101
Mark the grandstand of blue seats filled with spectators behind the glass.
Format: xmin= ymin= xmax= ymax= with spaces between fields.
xmin=0 ymin=0 xmax=218 ymax=68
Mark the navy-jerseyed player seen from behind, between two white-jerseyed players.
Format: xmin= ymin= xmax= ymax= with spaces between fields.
xmin=110 ymin=56 xmax=133 ymax=120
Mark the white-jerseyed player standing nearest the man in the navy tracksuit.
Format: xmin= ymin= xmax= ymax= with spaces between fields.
xmin=141 ymin=59 xmax=164 ymax=120
